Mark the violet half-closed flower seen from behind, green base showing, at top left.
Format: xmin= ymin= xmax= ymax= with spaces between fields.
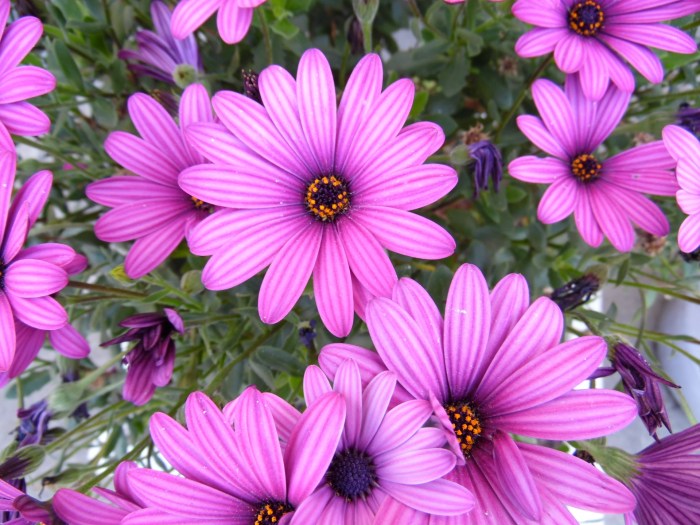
xmin=119 ymin=0 xmax=203 ymax=87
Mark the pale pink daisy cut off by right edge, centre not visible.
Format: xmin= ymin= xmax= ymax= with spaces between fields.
xmin=663 ymin=126 xmax=700 ymax=253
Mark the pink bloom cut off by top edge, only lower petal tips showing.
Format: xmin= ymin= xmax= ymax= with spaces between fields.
xmin=171 ymin=0 xmax=266 ymax=44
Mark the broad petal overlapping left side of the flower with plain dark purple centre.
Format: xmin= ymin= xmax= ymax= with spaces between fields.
xmin=284 ymin=392 xmax=345 ymax=507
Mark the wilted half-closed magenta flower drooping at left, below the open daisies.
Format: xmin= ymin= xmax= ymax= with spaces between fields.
xmin=101 ymin=308 xmax=185 ymax=405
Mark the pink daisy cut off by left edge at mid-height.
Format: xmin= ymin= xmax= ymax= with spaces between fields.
xmin=0 ymin=151 xmax=90 ymax=376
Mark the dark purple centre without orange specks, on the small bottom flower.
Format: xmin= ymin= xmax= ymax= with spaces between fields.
xmin=326 ymin=448 xmax=377 ymax=501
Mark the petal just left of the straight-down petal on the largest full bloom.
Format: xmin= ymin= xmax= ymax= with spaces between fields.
xmin=258 ymin=224 xmax=323 ymax=324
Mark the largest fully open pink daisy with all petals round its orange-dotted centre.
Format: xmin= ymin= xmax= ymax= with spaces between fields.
xmin=180 ymin=49 xmax=457 ymax=337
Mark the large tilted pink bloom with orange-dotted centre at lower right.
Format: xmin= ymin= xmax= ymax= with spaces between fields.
xmin=320 ymin=265 xmax=637 ymax=525
